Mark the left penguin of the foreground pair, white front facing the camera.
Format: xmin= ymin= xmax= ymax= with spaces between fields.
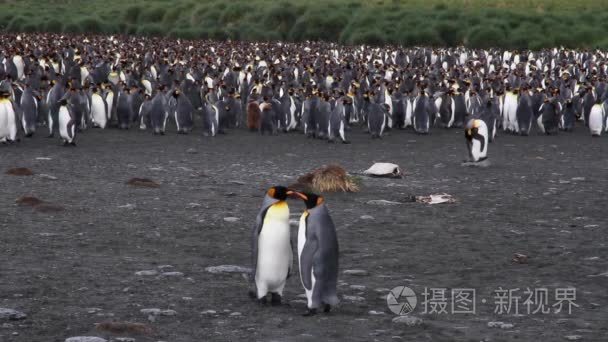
xmin=249 ymin=186 xmax=293 ymax=304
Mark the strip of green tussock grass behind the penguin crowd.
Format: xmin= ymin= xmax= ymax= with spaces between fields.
xmin=0 ymin=0 xmax=608 ymax=49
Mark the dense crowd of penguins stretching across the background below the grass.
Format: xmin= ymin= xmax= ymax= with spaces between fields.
xmin=0 ymin=33 xmax=608 ymax=144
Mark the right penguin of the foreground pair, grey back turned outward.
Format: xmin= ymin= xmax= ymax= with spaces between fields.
xmin=296 ymin=193 xmax=339 ymax=316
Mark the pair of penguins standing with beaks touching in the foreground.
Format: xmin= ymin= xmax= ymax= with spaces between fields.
xmin=249 ymin=186 xmax=339 ymax=316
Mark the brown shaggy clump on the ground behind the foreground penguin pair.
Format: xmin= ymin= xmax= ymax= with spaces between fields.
xmin=291 ymin=165 xmax=359 ymax=192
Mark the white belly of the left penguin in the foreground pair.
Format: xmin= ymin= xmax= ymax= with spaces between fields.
xmin=255 ymin=214 xmax=293 ymax=298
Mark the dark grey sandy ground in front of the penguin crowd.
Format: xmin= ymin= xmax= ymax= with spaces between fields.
xmin=0 ymin=127 xmax=608 ymax=342
